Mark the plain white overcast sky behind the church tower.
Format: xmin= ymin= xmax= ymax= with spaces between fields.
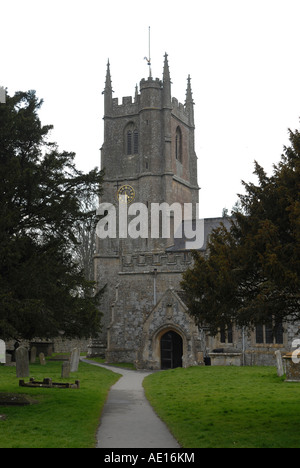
xmin=0 ymin=0 xmax=300 ymax=217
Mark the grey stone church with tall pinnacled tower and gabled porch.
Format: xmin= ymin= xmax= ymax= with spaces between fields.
xmin=89 ymin=54 xmax=293 ymax=369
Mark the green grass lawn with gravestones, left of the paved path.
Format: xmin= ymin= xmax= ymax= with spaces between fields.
xmin=0 ymin=361 xmax=119 ymax=448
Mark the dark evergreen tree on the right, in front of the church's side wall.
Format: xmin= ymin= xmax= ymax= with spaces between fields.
xmin=182 ymin=126 xmax=300 ymax=334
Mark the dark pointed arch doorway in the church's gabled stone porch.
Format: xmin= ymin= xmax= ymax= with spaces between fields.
xmin=160 ymin=330 xmax=183 ymax=369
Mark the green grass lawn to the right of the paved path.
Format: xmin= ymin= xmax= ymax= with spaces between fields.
xmin=144 ymin=366 xmax=300 ymax=448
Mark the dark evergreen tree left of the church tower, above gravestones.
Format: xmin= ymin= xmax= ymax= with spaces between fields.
xmin=0 ymin=91 xmax=103 ymax=339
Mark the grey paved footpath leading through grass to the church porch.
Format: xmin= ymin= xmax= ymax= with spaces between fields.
xmin=82 ymin=359 xmax=180 ymax=448
